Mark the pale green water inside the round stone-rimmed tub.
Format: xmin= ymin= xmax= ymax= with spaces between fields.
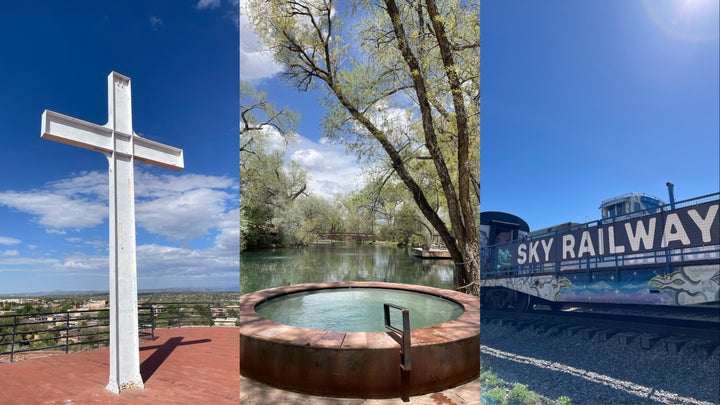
xmin=255 ymin=288 xmax=463 ymax=332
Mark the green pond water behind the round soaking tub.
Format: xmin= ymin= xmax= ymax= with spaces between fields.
xmin=240 ymin=243 xmax=455 ymax=294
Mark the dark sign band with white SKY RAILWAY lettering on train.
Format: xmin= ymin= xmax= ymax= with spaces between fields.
xmin=510 ymin=200 xmax=720 ymax=266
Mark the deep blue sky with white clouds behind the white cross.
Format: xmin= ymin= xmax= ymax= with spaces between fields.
xmin=0 ymin=0 xmax=239 ymax=294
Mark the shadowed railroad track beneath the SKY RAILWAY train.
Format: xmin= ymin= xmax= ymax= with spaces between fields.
xmin=480 ymin=306 xmax=720 ymax=358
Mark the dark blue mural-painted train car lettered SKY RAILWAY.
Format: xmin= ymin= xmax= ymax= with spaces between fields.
xmin=480 ymin=193 xmax=720 ymax=311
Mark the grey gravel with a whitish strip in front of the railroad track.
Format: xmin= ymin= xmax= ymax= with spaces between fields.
xmin=480 ymin=323 xmax=720 ymax=405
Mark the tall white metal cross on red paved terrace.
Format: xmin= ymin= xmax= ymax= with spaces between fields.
xmin=40 ymin=72 xmax=184 ymax=394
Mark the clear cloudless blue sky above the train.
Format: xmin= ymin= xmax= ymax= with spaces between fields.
xmin=480 ymin=0 xmax=720 ymax=229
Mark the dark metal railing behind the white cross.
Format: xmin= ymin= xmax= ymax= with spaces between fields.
xmin=0 ymin=302 xmax=237 ymax=362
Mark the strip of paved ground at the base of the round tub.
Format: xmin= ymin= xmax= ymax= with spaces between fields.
xmin=240 ymin=376 xmax=480 ymax=405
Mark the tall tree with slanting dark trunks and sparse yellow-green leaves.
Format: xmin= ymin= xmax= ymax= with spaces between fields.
xmin=249 ymin=0 xmax=480 ymax=294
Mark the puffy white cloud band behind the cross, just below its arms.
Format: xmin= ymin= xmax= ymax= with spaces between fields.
xmin=0 ymin=170 xmax=238 ymax=244
